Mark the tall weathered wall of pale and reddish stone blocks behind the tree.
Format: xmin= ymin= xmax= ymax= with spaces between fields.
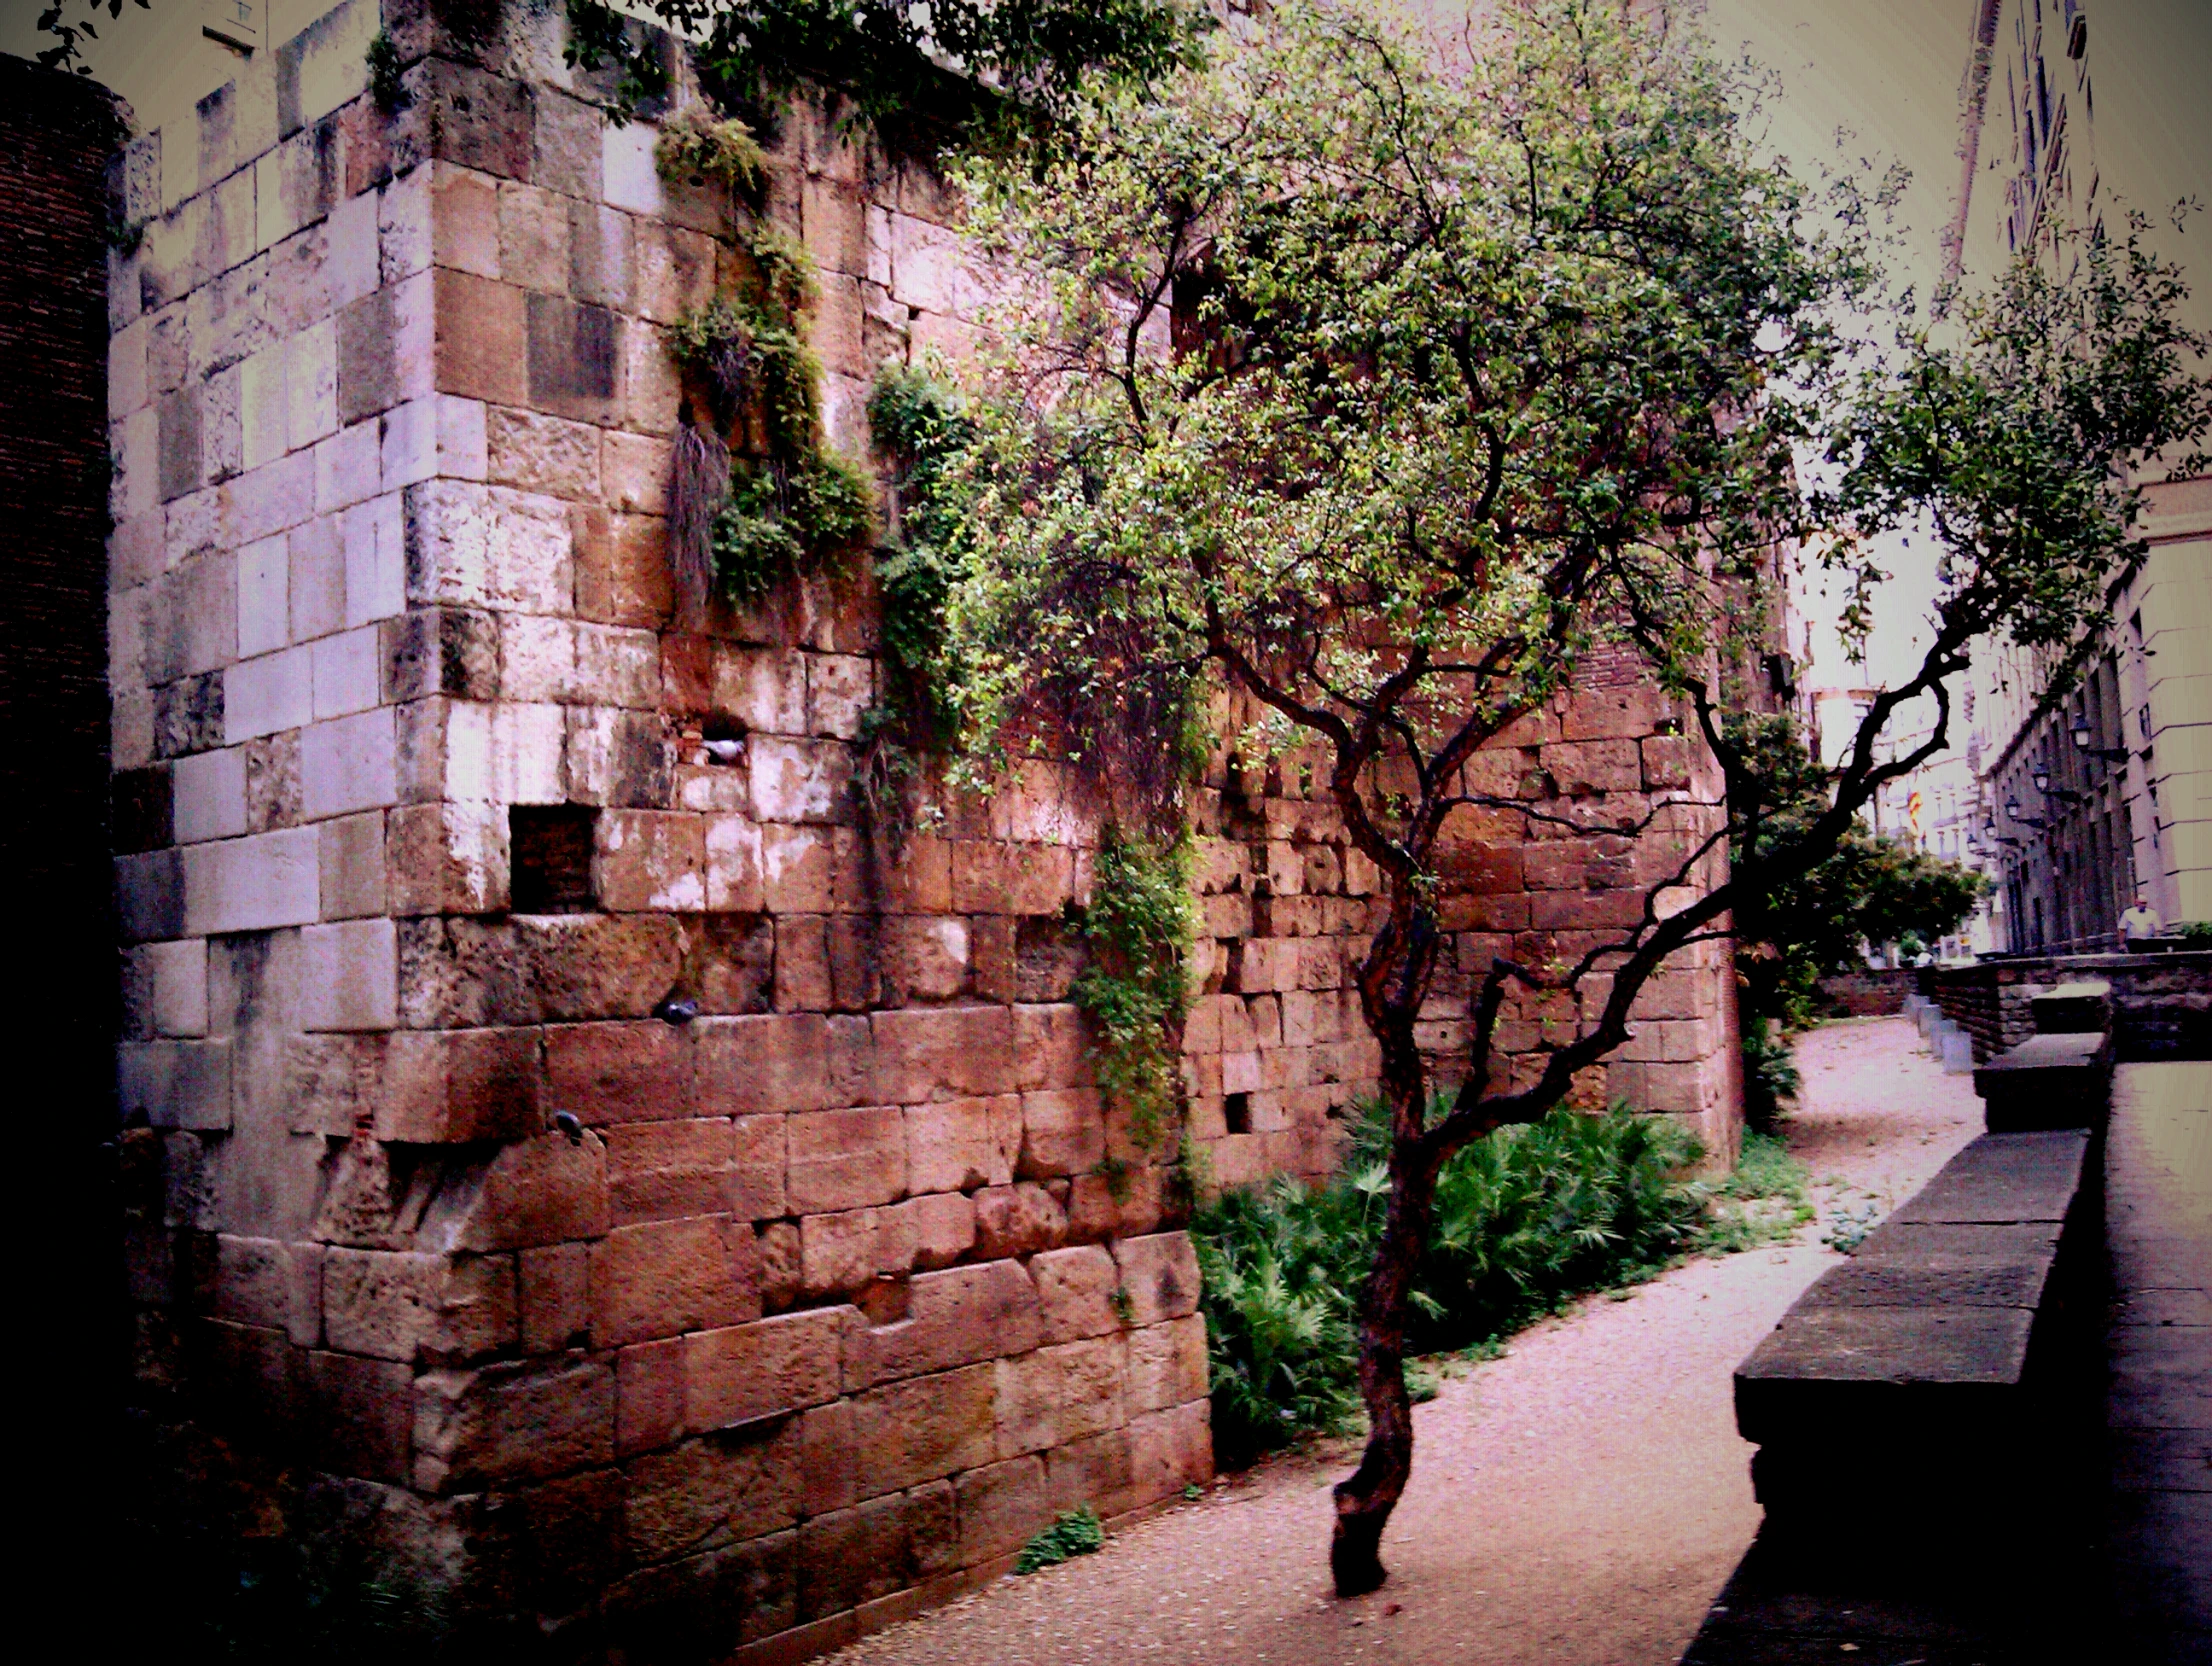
xmin=108 ymin=0 xmax=1734 ymax=1657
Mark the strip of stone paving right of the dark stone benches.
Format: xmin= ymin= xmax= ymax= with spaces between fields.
xmin=2106 ymin=1062 xmax=2212 ymax=1666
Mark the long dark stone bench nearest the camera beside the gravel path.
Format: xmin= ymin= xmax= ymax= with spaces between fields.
xmin=1736 ymin=1131 xmax=2097 ymax=1529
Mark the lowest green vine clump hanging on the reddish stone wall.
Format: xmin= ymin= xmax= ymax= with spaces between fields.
xmin=1068 ymin=827 xmax=1197 ymax=1148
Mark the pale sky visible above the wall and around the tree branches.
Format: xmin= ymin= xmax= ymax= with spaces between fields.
xmin=17 ymin=0 xmax=2212 ymax=716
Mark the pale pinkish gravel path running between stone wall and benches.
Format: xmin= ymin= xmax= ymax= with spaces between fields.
xmin=836 ymin=1018 xmax=1980 ymax=1666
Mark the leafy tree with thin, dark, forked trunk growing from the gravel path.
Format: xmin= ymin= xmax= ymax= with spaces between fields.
xmin=945 ymin=0 xmax=2208 ymax=1595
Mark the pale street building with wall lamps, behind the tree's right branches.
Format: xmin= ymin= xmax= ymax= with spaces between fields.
xmin=1947 ymin=0 xmax=2212 ymax=951
